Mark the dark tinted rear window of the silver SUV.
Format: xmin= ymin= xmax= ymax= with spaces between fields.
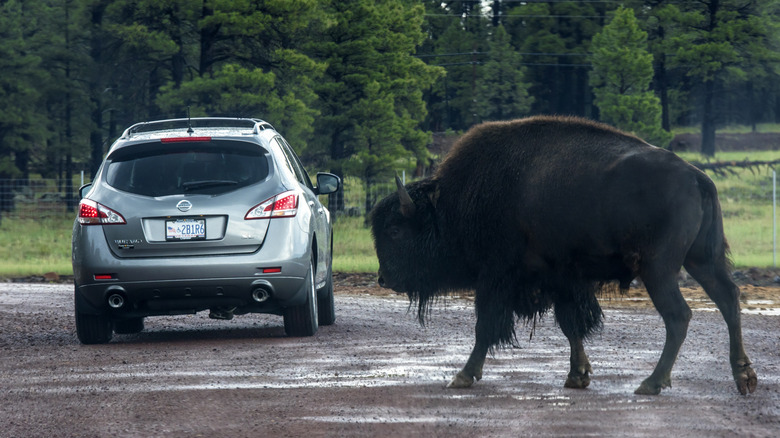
xmin=106 ymin=141 xmax=268 ymax=196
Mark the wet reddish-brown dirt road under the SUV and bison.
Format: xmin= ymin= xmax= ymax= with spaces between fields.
xmin=0 ymin=281 xmax=780 ymax=437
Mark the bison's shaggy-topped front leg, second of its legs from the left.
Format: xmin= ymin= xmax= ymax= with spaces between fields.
xmin=555 ymin=287 xmax=602 ymax=389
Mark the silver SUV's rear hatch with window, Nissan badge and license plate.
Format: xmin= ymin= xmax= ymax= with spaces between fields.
xmin=93 ymin=138 xmax=283 ymax=258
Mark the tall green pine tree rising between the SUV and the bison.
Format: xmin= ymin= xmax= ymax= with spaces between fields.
xmin=315 ymin=0 xmax=440 ymax=210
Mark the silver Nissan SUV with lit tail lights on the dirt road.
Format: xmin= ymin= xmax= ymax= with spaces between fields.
xmin=72 ymin=118 xmax=341 ymax=344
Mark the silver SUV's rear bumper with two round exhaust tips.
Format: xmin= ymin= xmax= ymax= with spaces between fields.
xmin=73 ymin=221 xmax=312 ymax=318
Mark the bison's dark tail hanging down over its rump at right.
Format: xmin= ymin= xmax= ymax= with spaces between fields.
xmin=686 ymin=173 xmax=732 ymax=272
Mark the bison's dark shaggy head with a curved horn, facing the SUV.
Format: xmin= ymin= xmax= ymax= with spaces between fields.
xmin=370 ymin=177 xmax=453 ymax=310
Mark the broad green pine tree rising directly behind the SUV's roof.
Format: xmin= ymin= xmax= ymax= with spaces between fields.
xmin=156 ymin=0 xmax=325 ymax=149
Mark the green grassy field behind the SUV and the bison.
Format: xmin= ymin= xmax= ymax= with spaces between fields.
xmin=0 ymin=151 xmax=780 ymax=277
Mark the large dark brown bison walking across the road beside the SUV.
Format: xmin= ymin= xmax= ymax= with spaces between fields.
xmin=369 ymin=116 xmax=757 ymax=394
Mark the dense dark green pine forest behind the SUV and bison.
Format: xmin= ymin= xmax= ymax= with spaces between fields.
xmin=0 ymin=0 xmax=780 ymax=215
